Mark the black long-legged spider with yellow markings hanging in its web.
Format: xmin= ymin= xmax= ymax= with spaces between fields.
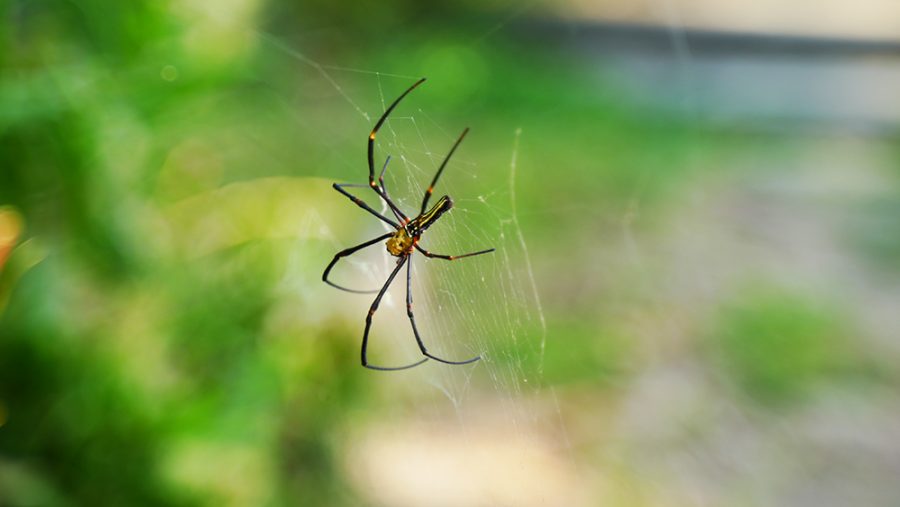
xmin=322 ymin=78 xmax=494 ymax=371
